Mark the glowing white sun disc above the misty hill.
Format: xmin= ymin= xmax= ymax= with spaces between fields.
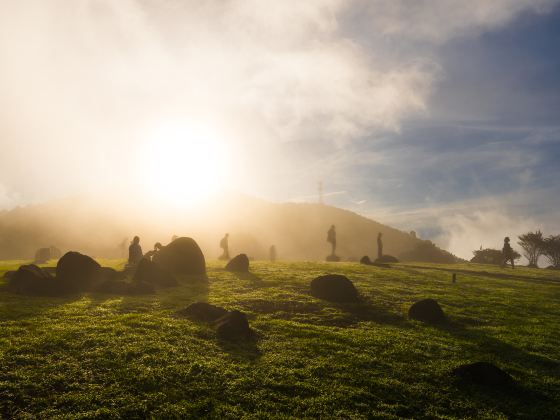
xmin=143 ymin=122 xmax=227 ymax=206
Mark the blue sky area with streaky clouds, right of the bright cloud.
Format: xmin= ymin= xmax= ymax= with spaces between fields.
xmin=268 ymin=6 xmax=560 ymax=257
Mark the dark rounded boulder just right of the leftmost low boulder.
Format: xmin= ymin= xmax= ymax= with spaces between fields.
xmin=56 ymin=251 xmax=103 ymax=292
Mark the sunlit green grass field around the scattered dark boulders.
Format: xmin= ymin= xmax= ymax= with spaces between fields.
xmin=0 ymin=261 xmax=560 ymax=419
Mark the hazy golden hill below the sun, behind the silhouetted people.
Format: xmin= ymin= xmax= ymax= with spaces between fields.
xmin=0 ymin=194 xmax=456 ymax=262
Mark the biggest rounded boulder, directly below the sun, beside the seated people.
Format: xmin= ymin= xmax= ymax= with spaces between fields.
xmin=153 ymin=238 xmax=206 ymax=275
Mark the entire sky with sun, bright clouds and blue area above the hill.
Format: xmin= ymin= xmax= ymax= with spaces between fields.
xmin=0 ymin=0 xmax=560 ymax=258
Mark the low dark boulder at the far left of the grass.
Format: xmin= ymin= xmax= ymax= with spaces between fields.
xmin=7 ymin=264 xmax=57 ymax=296
